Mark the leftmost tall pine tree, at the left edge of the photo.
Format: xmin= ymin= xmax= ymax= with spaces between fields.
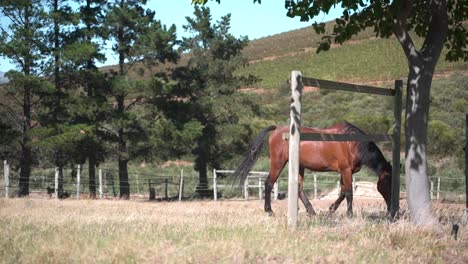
xmin=0 ymin=0 xmax=51 ymax=196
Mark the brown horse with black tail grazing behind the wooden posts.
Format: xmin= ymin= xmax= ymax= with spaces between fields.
xmin=234 ymin=122 xmax=392 ymax=216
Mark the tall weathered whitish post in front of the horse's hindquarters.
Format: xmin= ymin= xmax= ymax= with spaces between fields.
xmin=288 ymin=71 xmax=302 ymax=230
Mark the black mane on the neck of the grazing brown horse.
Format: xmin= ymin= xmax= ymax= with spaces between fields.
xmin=344 ymin=122 xmax=387 ymax=175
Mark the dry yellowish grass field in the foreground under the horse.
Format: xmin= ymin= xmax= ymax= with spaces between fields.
xmin=0 ymin=199 xmax=468 ymax=263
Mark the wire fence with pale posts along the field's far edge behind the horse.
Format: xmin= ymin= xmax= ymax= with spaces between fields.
xmin=0 ymin=163 xmax=466 ymax=202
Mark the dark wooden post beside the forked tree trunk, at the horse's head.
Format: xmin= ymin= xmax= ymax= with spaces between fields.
xmin=390 ymin=80 xmax=403 ymax=218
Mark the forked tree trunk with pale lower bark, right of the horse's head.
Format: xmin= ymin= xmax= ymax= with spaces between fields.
xmin=393 ymin=0 xmax=448 ymax=225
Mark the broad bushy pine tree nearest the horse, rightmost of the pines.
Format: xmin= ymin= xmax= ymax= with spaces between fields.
xmin=173 ymin=6 xmax=255 ymax=193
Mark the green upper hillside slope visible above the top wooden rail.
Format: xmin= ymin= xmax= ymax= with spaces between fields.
xmin=239 ymin=24 xmax=468 ymax=89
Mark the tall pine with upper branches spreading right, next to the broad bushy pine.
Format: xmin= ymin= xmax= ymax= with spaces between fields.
xmin=106 ymin=0 xmax=177 ymax=199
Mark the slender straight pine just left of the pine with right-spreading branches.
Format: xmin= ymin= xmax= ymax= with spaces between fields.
xmin=70 ymin=0 xmax=109 ymax=197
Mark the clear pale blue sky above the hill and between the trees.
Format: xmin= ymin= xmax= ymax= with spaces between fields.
xmin=0 ymin=0 xmax=341 ymax=72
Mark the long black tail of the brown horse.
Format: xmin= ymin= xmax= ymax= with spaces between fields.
xmin=234 ymin=125 xmax=276 ymax=183
